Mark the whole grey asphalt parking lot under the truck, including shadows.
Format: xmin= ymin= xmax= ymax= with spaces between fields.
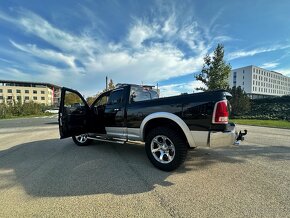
xmin=0 ymin=118 xmax=290 ymax=217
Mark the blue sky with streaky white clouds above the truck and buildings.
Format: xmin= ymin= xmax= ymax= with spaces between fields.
xmin=0 ymin=0 xmax=290 ymax=96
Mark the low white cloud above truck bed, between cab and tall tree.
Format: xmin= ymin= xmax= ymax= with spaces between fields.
xmin=159 ymin=80 xmax=205 ymax=97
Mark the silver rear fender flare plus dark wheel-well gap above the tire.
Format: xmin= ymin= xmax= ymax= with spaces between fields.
xmin=140 ymin=112 xmax=196 ymax=147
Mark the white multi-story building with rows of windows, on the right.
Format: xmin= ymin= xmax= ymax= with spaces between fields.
xmin=229 ymin=65 xmax=290 ymax=98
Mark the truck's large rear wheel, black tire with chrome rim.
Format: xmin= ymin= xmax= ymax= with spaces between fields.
xmin=145 ymin=127 xmax=188 ymax=171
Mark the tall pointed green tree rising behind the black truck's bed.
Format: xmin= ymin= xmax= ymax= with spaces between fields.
xmin=195 ymin=44 xmax=231 ymax=91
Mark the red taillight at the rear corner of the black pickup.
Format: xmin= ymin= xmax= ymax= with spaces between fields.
xmin=212 ymin=100 xmax=229 ymax=124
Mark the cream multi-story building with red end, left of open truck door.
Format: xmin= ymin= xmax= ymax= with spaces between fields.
xmin=0 ymin=80 xmax=61 ymax=106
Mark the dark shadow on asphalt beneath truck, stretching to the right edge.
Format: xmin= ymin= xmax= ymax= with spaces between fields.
xmin=0 ymin=139 xmax=290 ymax=197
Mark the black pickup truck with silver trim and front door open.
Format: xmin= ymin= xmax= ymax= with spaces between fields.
xmin=59 ymin=84 xmax=243 ymax=171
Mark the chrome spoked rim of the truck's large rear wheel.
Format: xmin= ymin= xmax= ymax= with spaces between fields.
xmin=151 ymin=135 xmax=175 ymax=164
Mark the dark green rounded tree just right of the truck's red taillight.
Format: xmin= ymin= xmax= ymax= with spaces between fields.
xmin=229 ymin=86 xmax=251 ymax=117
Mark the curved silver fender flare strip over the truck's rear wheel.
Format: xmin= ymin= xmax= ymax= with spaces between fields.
xmin=140 ymin=112 xmax=196 ymax=147
